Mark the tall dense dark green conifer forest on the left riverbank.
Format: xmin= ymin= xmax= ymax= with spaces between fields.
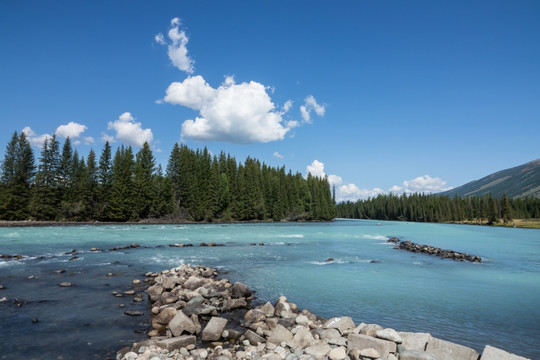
xmin=0 ymin=132 xmax=336 ymax=222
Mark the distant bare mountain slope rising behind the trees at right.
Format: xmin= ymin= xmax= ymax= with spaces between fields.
xmin=439 ymin=159 xmax=540 ymax=198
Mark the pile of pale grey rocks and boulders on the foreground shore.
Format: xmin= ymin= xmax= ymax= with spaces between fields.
xmin=117 ymin=265 xmax=526 ymax=360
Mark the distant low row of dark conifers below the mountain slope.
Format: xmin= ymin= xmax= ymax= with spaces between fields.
xmin=336 ymin=194 xmax=540 ymax=224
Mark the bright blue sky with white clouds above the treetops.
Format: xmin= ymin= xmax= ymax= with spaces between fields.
xmin=0 ymin=0 xmax=540 ymax=200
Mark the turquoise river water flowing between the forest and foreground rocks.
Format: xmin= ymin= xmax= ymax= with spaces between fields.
xmin=0 ymin=220 xmax=540 ymax=359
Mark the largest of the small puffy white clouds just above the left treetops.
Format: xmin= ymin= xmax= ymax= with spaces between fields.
xmin=106 ymin=112 xmax=154 ymax=147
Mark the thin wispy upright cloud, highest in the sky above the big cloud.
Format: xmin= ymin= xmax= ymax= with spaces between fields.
xmin=154 ymin=18 xmax=194 ymax=74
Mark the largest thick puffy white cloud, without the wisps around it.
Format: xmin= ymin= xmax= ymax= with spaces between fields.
xmin=162 ymin=75 xmax=290 ymax=144
